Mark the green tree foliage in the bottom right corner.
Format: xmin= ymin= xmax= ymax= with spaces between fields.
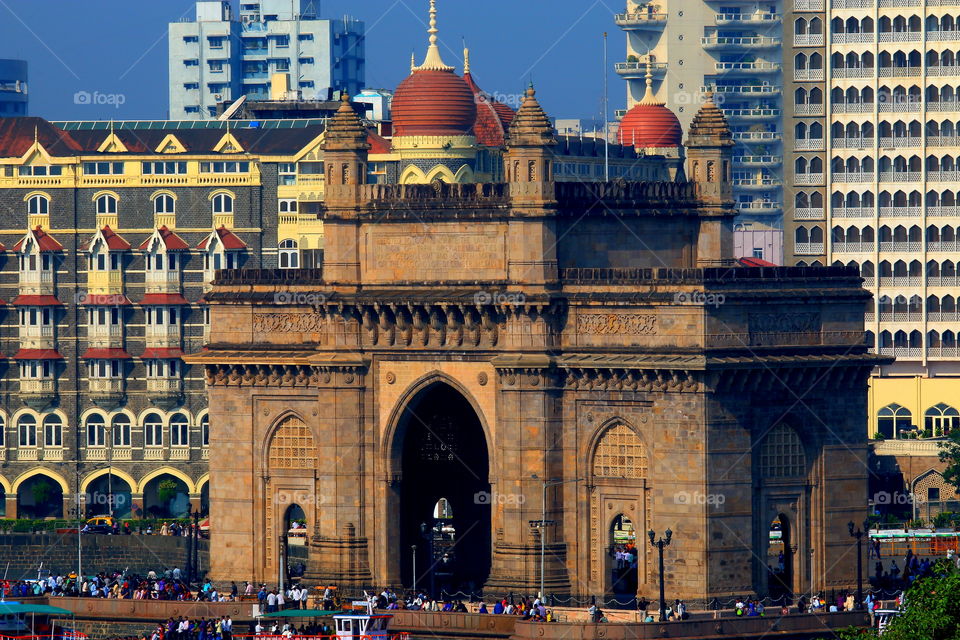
xmin=872 ymin=560 xmax=960 ymax=640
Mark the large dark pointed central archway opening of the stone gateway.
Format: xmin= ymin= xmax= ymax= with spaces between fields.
xmin=390 ymin=381 xmax=494 ymax=593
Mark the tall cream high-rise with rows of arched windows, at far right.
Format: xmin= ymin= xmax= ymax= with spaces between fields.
xmin=784 ymin=0 xmax=960 ymax=513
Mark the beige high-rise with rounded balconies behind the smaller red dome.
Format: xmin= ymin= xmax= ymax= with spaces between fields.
xmin=616 ymin=0 xmax=783 ymax=264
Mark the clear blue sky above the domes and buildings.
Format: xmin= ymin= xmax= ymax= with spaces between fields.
xmin=0 ymin=0 xmax=626 ymax=120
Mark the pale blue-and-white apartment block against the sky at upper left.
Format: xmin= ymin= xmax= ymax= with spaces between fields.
xmin=168 ymin=0 xmax=365 ymax=120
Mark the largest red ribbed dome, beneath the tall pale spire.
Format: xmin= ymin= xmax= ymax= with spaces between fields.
xmin=391 ymin=69 xmax=477 ymax=136
